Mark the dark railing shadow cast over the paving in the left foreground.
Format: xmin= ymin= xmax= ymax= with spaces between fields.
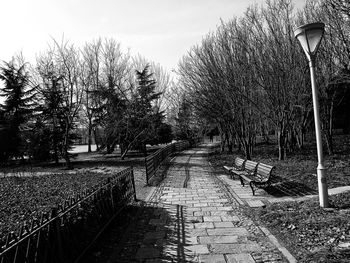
xmin=80 ymin=203 xmax=198 ymax=263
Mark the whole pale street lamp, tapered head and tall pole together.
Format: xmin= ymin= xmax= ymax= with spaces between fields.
xmin=294 ymin=23 xmax=329 ymax=207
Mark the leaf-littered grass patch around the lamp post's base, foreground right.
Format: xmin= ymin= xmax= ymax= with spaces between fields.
xmin=245 ymin=192 xmax=350 ymax=263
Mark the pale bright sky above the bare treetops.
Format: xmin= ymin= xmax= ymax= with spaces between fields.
xmin=0 ymin=0 xmax=306 ymax=70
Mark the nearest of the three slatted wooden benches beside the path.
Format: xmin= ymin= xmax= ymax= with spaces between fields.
xmin=238 ymin=161 xmax=275 ymax=195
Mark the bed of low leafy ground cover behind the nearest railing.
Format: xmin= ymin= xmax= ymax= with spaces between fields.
xmin=0 ymin=172 xmax=108 ymax=238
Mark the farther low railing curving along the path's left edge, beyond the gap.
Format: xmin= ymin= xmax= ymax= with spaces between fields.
xmin=145 ymin=141 xmax=190 ymax=185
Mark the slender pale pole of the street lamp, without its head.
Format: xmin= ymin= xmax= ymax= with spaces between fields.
xmin=309 ymin=56 xmax=329 ymax=207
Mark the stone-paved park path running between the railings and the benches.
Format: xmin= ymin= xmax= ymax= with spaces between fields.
xmin=94 ymin=145 xmax=289 ymax=263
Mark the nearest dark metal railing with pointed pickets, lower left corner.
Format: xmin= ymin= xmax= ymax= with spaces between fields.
xmin=0 ymin=168 xmax=136 ymax=263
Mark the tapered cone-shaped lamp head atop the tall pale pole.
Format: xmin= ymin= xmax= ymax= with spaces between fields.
xmin=294 ymin=23 xmax=324 ymax=61
